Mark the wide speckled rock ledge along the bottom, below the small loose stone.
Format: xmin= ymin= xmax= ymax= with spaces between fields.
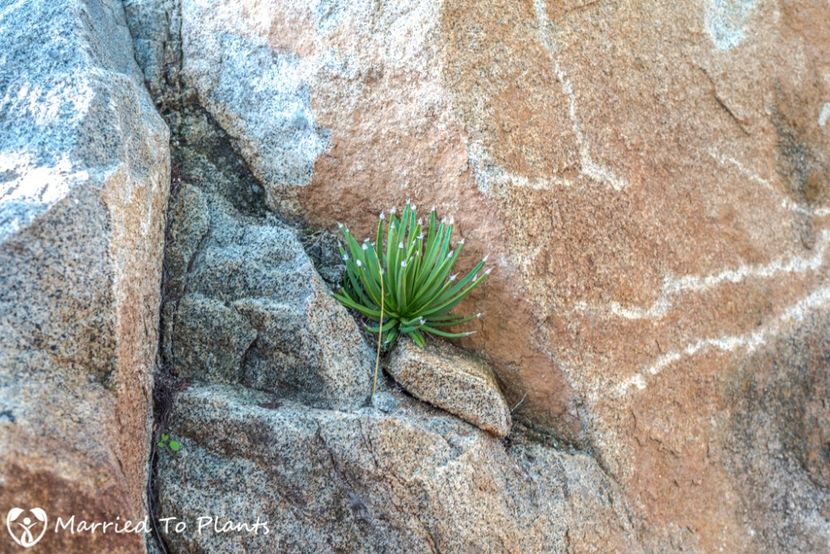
xmin=159 ymin=385 xmax=641 ymax=553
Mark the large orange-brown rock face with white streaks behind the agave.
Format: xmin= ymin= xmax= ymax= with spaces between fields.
xmin=125 ymin=0 xmax=830 ymax=551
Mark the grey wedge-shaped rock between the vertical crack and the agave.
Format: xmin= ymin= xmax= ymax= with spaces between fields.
xmin=163 ymin=110 xmax=373 ymax=408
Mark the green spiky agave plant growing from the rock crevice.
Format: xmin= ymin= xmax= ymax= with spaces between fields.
xmin=335 ymin=200 xmax=492 ymax=347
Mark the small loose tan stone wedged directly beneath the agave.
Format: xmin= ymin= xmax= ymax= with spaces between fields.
xmin=385 ymin=340 xmax=511 ymax=437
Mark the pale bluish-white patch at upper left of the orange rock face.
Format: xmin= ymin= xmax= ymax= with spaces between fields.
xmin=181 ymin=0 xmax=329 ymax=201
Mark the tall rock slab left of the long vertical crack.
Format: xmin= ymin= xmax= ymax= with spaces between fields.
xmin=0 ymin=0 xmax=170 ymax=552
